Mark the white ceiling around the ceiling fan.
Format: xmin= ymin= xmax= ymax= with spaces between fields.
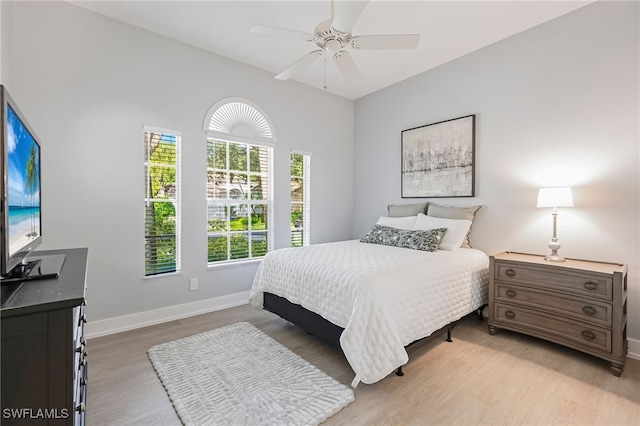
xmin=71 ymin=0 xmax=593 ymax=99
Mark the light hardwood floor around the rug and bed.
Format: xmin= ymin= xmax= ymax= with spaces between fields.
xmin=87 ymin=305 xmax=640 ymax=426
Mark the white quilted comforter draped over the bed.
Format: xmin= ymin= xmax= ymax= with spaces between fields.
xmin=250 ymin=240 xmax=489 ymax=387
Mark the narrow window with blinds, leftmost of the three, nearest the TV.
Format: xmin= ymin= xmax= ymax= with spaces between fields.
xmin=144 ymin=127 xmax=180 ymax=276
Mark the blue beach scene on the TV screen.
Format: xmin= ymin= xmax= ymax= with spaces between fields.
xmin=7 ymin=108 xmax=40 ymax=255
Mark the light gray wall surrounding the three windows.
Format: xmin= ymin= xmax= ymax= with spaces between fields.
xmin=12 ymin=2 xmax=353 ymax=321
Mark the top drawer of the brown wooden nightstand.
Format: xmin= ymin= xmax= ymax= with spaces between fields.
xmin=494 ymin=262 xmax=613 ymax=301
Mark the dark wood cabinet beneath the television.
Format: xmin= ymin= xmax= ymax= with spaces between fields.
xmin=0 ymin=248 xmax=88 ymax=425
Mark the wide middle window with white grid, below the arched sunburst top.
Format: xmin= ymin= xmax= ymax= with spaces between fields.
xmin=207 ymin=137 xmax=273 ymax=265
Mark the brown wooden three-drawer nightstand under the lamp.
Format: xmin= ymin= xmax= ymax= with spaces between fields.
xmin=488 ymin=252 xmax=627 ymax=376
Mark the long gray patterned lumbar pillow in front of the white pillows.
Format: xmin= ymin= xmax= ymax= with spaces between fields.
xmin=360 ymin=225 xmax=447 ymax=251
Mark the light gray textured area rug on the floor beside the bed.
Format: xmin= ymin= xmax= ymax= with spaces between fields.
xmin=149 ymin=322 xmax=355 ymax=426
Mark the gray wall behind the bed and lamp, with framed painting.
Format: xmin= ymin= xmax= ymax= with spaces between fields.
xmin=353 ymin=2 xmax=640 ymax=339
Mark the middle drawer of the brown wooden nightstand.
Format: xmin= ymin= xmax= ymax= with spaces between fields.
xmin=495 ymin=283 xmax=612 ymax=327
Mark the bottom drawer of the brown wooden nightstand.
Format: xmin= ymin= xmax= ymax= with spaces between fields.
xmin=494 ymin=303 xmax=611 ymax=353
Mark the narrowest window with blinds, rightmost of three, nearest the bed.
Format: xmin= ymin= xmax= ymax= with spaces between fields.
xmin=291 ymin=151 xmax=311 ymax=247
